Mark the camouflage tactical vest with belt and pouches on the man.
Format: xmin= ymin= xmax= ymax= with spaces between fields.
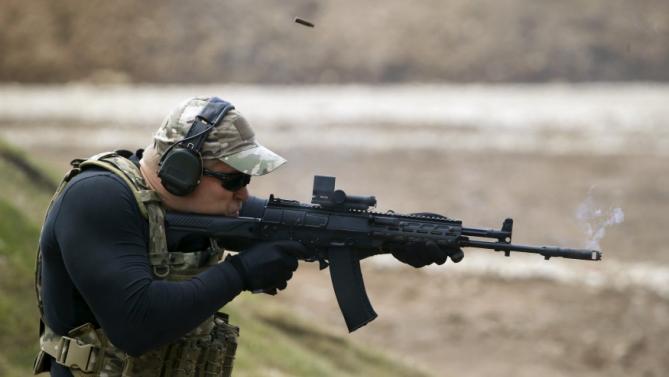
xmin=34 ymin=151 xmax=239 ymax=377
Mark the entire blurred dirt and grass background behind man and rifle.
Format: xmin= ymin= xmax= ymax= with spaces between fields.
xmin=0 ymin=0 xmax=669 ymax=377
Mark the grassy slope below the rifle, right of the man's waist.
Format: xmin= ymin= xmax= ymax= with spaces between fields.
xmin=223 ymin=295 xmax=427 ymax=377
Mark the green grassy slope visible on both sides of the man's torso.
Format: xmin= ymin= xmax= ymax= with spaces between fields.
xmin=0 ymin=141 xmax=434 ymax=377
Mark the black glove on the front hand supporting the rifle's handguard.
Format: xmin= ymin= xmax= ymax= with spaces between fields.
xmin=392 ymin=212 xmax=464 ymax=268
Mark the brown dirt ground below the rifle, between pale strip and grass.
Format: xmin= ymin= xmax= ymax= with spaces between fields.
xmin=273 ymin=265 xmax=669 ymax=377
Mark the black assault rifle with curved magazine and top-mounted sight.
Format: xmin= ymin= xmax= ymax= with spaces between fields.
xmin=165 ymin=176 xmax=602 ymax=332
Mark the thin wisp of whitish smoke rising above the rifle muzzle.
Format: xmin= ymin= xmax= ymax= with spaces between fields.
xmin=576 ymin=187 xmax=625 ymax=250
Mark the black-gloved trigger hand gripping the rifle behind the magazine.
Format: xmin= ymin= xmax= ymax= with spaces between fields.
xmin=226 ymin=241 xmax=307 ymax=295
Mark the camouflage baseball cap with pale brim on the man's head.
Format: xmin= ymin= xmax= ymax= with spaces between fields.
xmin=153 ymin=97 xmax=286 ymax=175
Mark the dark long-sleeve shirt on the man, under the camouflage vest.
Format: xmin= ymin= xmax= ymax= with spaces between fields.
xmin=40 ymin=163 xmax=242 ymax=377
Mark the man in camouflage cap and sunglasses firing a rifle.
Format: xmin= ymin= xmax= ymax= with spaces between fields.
xmin=35 ymin=97 xmax=449 ymax=377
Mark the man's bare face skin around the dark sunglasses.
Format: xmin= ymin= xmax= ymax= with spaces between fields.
xmin=183 ymin=160 xmax=249 ymax=216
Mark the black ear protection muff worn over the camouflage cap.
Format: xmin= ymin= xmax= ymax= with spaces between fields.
xmin=158 ymin=97 xmax=235 ymax=196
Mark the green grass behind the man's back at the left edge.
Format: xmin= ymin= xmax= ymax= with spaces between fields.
xmin=0 ymin=140 xmax=55 ymax=377
